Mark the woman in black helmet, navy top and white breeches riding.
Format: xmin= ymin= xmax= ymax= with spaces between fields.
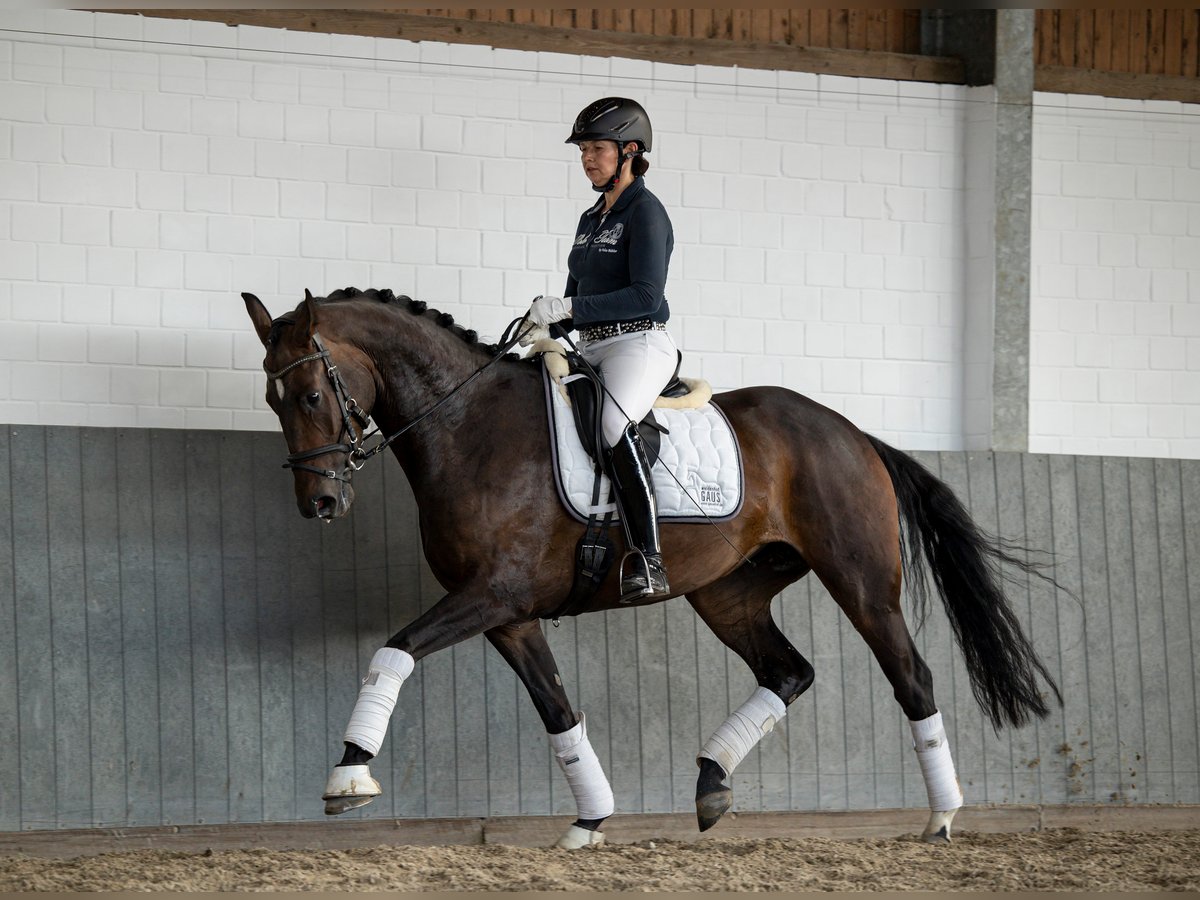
xmin=529 ymin=97 xmax=678 ymax=602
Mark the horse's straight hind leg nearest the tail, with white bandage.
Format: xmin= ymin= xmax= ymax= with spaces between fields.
xmin=814 ymin=552 xmax=962 ymax=844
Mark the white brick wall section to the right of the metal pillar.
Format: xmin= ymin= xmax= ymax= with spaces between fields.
xmin=1030 ymin=94 xmax=1200 ymax=458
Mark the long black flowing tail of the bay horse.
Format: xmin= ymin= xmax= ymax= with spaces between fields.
xmin=868 ymin=434 xmax=1062 ymax=730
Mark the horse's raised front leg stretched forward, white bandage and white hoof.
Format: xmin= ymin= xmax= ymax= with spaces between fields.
xmin=322 ymin=589 xmax=517 ymax=816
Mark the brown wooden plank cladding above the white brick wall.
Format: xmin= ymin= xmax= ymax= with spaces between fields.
xmin=100 ymin=8 xmax=1200 ymax=102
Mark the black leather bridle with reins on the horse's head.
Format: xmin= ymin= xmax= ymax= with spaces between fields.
xmin=263 ymin=316 xmax=528 ymax=490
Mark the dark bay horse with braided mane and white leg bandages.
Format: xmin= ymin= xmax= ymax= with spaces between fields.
xmin=242 ymin=288 xmax=1062 ymax=848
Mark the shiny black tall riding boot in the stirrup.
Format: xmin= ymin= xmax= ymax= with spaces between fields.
xmin=608 ymin=424 xmax=671 ymax=604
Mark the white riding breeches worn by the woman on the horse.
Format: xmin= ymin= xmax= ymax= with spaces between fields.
xmin=578 ymin=331 xmax=678 ymax=446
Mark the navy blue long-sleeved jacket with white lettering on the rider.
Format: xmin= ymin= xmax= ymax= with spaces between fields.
xmin=563 ymin=176 xmax=674 ymax=328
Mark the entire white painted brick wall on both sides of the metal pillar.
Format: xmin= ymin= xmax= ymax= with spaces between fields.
xmin=0 ymin=11 xmax=1200 ymax=456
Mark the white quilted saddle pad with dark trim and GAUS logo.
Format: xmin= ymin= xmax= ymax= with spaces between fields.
xmin=542 ymin=366 xmax=743 ymax=522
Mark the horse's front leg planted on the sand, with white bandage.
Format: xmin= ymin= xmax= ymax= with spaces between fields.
xmin=487 ymin=619 xmax=613 ymax=850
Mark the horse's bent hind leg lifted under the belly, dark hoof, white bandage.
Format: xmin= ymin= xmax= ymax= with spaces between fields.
xmin=688 ymin=546 xmax=812 ymax=832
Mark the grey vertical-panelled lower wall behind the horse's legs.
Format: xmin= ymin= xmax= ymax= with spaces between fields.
xmin=0 ymin=426 xmax=1200 ymax=830
